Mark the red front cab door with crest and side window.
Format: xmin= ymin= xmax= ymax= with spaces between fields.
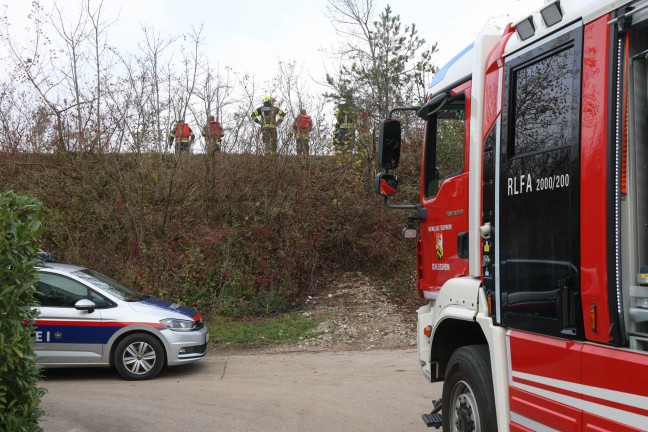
xmin=419 ymin=89 xmax=470 ymax=298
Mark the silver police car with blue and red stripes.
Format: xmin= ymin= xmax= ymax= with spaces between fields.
xmin=34 ymin=262 xmax=209 ymax=380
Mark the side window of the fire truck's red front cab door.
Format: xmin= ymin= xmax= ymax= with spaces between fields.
xmin=425 ymin=95 xmax=466 ymax=198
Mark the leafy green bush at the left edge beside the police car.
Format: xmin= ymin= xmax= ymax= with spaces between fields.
xmin=0 ymin=192 xmax=44 ymax=432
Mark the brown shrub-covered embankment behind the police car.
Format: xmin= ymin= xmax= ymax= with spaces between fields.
xmin=0 ymin=153 xmax=414 ymax=315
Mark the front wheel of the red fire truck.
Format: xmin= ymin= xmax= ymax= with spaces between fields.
xmin=443 ymin=345 xmax=497 ymax=432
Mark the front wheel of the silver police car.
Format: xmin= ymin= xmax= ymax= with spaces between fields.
xmin=113 ymin=333 xmax=165 ymax=380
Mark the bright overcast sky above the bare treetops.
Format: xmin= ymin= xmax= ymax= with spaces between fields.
xmin=3 ymin=0 xmax=544 ymax=93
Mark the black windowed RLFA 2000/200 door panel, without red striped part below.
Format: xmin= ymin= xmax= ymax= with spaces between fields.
xmin=496 ymin=25 xmax=582 ymax=344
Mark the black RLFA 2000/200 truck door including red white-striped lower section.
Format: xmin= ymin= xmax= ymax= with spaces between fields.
xmin=495 ymin=23 xmax=583 ymax=430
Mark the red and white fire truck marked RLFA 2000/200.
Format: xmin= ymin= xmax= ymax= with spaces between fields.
xmin=376 ymin=0 xmax=648 ymax=432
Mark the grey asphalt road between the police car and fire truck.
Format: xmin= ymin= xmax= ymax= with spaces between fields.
xmin=40 ymin=349 xmax=441 ymax=432
